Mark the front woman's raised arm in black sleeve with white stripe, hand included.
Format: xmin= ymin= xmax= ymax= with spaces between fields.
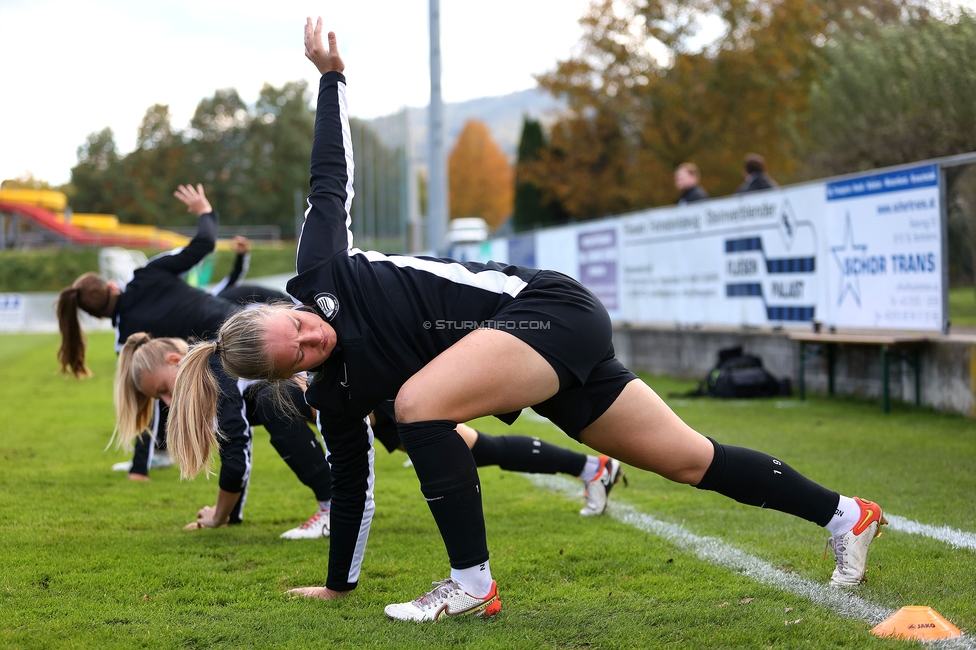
xmin=296 ymin=18 xmax=353 ymax=273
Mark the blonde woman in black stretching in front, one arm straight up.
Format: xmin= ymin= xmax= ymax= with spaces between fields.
xmin=171 ymin=19 xmax=884 ymax=621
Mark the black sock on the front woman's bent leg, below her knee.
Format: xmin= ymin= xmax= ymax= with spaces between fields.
xmin=397 ymin=420 xmax=488 ymax=569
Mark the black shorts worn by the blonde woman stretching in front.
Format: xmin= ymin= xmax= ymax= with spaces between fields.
xmin=490 ymin=271 xmax=637 ymax=440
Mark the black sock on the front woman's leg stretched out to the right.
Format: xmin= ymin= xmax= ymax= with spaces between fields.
xmin=695 ymin=438 xmax=840 ymax=526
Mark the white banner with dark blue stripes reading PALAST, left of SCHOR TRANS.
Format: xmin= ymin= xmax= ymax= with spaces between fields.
xmin=621 ymin=185 xmax=825 ymax=326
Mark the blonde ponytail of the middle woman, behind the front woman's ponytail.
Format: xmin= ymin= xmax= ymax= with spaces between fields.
xmin=109 ymin=332 xmax=188 ymax=447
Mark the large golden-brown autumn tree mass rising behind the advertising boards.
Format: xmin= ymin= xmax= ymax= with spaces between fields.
xmin=526 ymin=0 xmax=925 ymax=219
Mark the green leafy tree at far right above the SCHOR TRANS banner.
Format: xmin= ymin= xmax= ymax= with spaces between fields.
xmin=810 ymin=10 xmax=976 ymax=176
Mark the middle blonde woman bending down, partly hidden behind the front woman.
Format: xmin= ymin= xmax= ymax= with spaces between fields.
xmin=115 ymin=332 xmax=332 ymax=539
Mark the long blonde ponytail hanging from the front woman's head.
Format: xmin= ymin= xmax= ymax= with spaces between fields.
xmin=166 ymin=343 xmax=220 ymax=478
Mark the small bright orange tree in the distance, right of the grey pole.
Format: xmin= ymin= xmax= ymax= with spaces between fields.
xmin=447 ymin=120 xmax=514 ymax=230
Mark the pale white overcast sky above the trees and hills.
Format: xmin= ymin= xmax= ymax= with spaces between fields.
xmin=0 ymin=0 xmax=589 ymax=184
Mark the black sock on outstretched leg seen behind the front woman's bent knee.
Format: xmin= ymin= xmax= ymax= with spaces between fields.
xmin=471 ymin=431 xmax=586 ymax=476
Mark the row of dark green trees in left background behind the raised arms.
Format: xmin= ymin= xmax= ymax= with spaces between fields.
xmin=65 ymin=81 xmax=406 ymax=243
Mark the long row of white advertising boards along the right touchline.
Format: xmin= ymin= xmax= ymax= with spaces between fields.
xmin=446 ymin=159 xmax=943 ymax=331
